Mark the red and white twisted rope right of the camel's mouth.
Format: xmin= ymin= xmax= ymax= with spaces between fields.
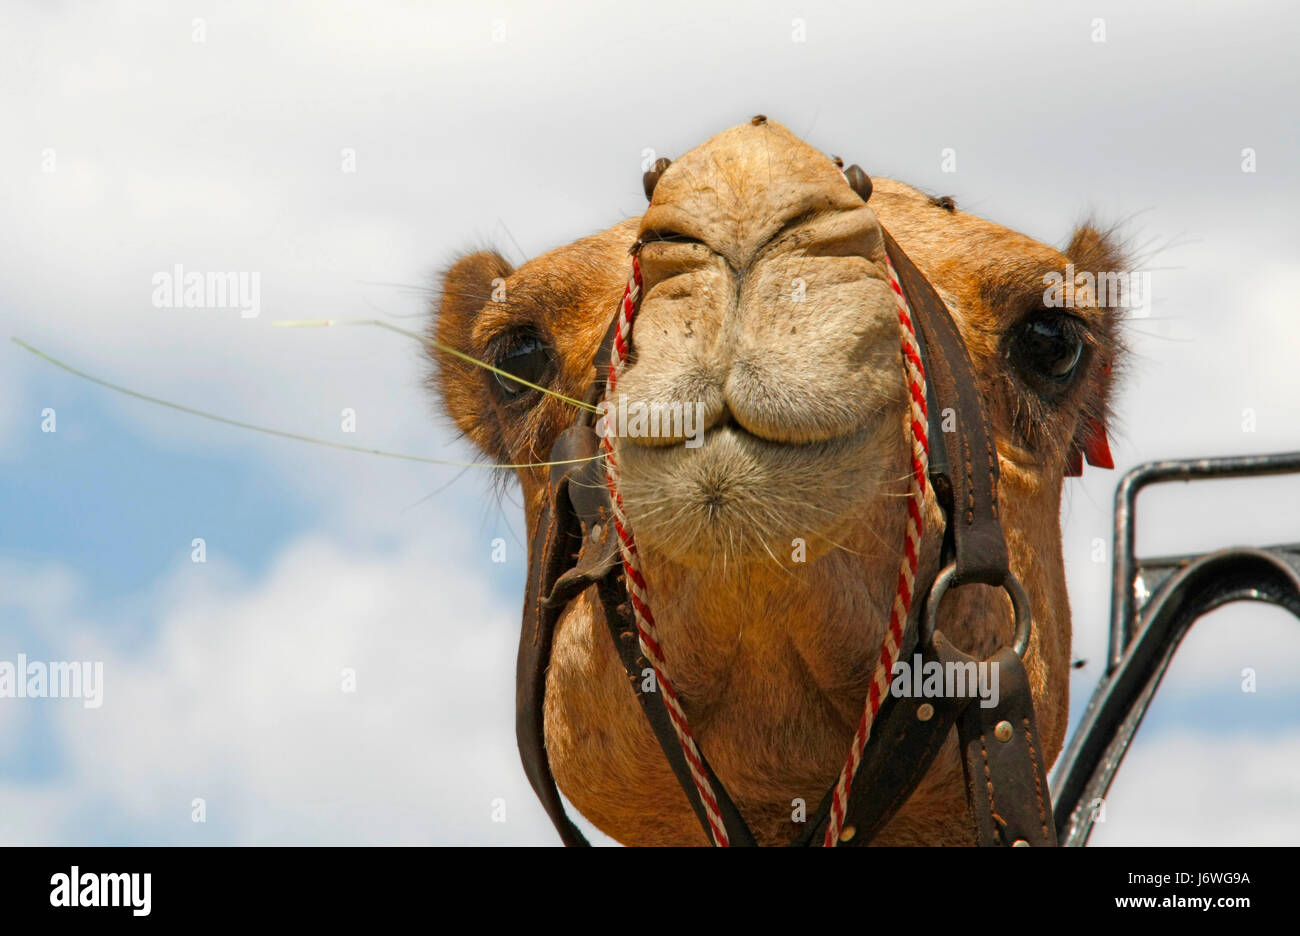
xmin=822 ymin=256 xmax=930 ymax=848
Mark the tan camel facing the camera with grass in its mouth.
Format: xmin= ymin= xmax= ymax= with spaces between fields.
xmin=429 ymin=118 xmax=1122 ymax=845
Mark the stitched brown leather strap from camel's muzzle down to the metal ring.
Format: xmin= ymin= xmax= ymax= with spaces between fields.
xmin=881 ymin=229 xmax=1009 ymax=585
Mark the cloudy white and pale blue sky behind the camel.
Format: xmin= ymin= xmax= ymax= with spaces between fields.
xmin=0 ymin=0 xmax=1300 ymax=845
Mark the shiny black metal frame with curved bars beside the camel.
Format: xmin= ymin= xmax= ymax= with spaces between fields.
xmin=1052 ymin=452 xmax=1300 ymax=845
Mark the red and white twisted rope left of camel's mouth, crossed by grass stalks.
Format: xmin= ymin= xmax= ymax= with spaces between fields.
xmin=601 ymin=254 xmax=731 ymax=845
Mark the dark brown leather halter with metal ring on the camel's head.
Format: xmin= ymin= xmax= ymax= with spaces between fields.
xmin=515 ymin=180 xmax=1057 ymax=846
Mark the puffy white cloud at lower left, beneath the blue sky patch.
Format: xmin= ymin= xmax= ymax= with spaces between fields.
xmin=0 ymin=540 xmax=613 ymax=844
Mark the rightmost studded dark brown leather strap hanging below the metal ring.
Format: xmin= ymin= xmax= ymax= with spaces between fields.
xmin=957 ymin=647 xmax=1057 ymax=848
